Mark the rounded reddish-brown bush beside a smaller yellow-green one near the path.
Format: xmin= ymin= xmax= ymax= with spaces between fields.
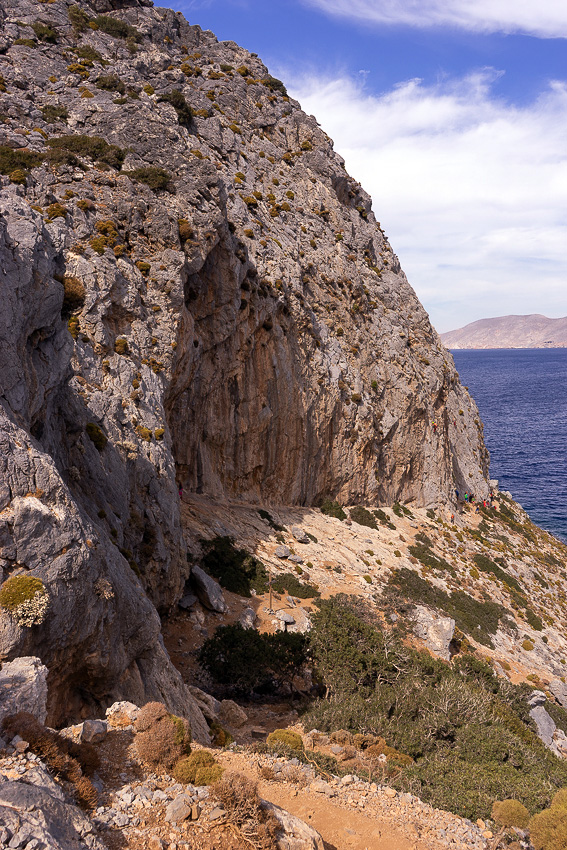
xmin=134 ymin=703 xmax=191 ymax=771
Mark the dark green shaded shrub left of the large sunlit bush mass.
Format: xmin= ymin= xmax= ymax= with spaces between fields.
xmin=199 ymin=623 xmax=306 ymax=693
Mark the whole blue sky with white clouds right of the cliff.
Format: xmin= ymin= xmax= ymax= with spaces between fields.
xmin=171 ymin=0 xmax=567 ymax=333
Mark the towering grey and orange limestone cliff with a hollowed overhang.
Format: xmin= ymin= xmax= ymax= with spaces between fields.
xmin=0 ymin=0 xmax=488 ymax=720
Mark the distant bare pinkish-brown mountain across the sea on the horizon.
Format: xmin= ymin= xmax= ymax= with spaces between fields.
xmin=441 ymin=313 xmax=567 ymax=348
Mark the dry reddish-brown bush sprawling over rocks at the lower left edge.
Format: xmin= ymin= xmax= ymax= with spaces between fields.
xmin=2 ymin=711 xmax=99 ymax=809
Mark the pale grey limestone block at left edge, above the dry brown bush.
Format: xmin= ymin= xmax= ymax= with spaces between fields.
xmin=0 ymin=657 xmax=47 ymax=725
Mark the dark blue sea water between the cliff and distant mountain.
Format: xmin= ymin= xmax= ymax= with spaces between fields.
xmin=451 ymin=348 xmax=567 ymax=540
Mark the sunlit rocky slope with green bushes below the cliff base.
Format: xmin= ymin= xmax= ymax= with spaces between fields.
xmin=176 ymin=494 xmax=567 ymax=819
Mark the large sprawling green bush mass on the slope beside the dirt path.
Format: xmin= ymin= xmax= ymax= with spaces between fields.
xmin=303 ymin=595 xmax=567 ymax=819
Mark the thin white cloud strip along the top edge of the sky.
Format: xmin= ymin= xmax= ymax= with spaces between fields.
xmin=303 ymin=0 xmax=567 ymax=38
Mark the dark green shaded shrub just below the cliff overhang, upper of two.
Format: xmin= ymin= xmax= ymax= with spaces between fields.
xmin=201 ymin=537 xmax=268 ymax=596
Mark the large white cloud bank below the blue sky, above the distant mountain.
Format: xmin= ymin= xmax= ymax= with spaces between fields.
xmin=285 ymin=69 xmax=567 ymax=332
